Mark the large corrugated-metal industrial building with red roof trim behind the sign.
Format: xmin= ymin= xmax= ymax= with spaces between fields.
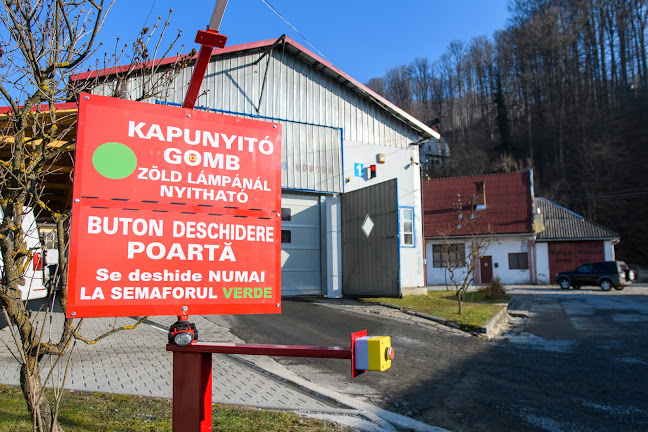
xmin=73 ymin=36 xmax=440 ymax=297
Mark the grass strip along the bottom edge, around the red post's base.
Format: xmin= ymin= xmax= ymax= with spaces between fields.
xmin=0 ymin=384 xmax=349 ymax=432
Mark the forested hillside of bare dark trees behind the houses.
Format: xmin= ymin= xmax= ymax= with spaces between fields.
xmin=367 ymin=0 xmax=648 ymax=265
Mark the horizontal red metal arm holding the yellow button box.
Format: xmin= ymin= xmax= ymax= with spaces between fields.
xmin=166 ymin=342 xmax=352 ymax=359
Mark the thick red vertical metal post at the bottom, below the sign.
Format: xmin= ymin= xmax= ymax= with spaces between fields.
xmin=173 ymin=352 xmax=212 ymax=432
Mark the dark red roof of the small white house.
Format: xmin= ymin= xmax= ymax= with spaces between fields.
xmin=423 ymin=172 xmax=533 ymax=237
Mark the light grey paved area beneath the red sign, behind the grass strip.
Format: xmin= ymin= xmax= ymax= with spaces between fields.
xmin=0 ymin=313 xmax=442 ymax=431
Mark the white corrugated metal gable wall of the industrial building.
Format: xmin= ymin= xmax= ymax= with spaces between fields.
xmin=93 ymin=46 xmax=418 ymax=192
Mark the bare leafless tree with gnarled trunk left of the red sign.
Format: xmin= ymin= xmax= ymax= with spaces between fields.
xmin=0 ymin=0 xmax=188 ymax=431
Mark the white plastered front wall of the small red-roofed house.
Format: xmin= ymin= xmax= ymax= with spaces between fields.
xmin=425 ymin=235 xmax=533 ymax=285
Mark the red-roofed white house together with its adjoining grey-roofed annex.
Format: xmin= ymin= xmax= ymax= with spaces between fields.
xmin=423 ymin=171 xmax=619 ymax=285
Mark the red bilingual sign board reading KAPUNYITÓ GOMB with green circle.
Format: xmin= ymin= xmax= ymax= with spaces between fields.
xmin=67 ymin=95 xmax=281 ymax=317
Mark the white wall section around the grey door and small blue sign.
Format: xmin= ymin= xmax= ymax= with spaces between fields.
xmin=343 ymin=140 xmax=424 ymax=288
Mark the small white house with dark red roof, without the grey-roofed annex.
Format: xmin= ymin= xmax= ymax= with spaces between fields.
xmin=423 ymin=171 xmax=537 ymax=285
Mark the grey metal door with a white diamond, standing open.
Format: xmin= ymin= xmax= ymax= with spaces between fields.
xmin=342 ymin=179 xmax=401 ymax=297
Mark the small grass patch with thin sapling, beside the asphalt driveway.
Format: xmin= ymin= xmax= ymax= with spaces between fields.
xmin=362 ymin=291 xmax=511 ymax=327
